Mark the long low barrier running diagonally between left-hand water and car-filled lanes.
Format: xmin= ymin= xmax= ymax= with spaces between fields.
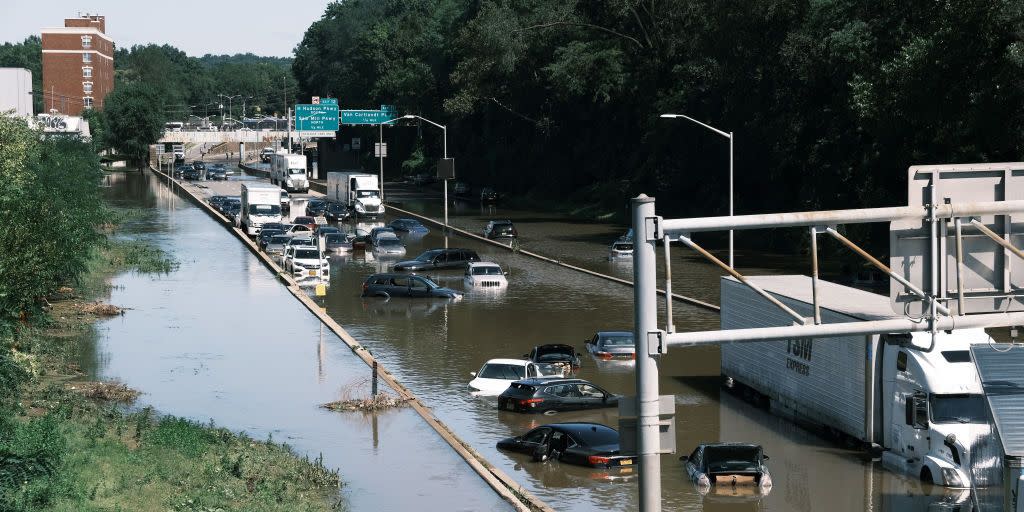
xmin=150 ymin=166 xmax=554 ymax=512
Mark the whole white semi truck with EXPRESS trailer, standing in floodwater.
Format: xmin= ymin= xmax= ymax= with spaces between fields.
xmin=721 ymin=275 xmax=993 ymax=488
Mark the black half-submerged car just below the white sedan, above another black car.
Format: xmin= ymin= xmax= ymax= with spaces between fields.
xmin=498 ymin=379 xmax=618 ymax=413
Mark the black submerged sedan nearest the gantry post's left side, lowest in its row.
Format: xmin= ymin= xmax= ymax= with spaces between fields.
xmin=498 ymin=423 xmax=635 ymax=468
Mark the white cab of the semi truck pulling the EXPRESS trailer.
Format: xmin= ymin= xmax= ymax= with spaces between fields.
xmin=880 ymin=329 xmax=991 ymax=487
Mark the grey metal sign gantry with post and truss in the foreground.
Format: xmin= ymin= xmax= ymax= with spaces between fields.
xmin=631 ymin=163 xmax=1024 ymax=512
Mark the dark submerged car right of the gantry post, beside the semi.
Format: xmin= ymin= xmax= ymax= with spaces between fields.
xmin=679 ymin=442 xmax=772 ymax=495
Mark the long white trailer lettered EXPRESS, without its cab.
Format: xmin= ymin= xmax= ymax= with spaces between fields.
xmin=722 ymin=275 xmax=893 ymax=440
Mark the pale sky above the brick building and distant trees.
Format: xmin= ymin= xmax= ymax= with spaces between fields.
xmin=0 ymin=0 xmax=329 ymax=57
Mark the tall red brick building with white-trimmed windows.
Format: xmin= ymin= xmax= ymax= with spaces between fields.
xmin=41 ymin=14 xmax=114 ymax=116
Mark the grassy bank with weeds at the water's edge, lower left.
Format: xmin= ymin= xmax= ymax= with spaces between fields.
xmin=0 ymin=205 xmax=343 ymax=511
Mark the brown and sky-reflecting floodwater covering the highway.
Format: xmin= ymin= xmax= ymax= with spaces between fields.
xmin=94 ymin=164 xmax=966 ymax=511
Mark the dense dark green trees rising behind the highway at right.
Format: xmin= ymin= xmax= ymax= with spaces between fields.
xmin=293 ymin=0 xmax=1024 ymax=230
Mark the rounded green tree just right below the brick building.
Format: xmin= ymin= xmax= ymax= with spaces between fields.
xmin=103 ymin=82 xmax=166 ymax=169
